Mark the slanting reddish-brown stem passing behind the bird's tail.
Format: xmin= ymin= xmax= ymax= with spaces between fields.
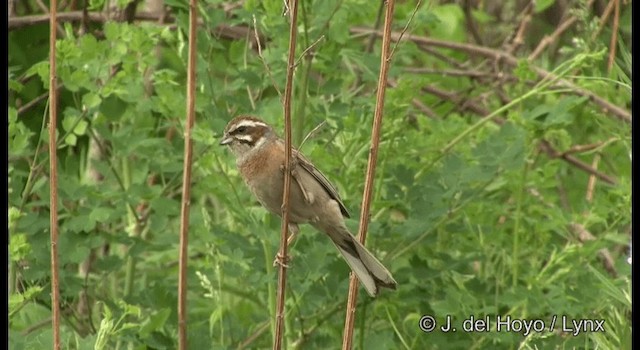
xmin=342 ymin=0 xmax=395 ymax=350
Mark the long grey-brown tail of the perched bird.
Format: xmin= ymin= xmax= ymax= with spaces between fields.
xmin=329 ymin=231 xmax=397 ymax=297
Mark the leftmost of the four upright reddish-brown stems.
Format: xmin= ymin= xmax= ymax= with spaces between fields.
xmin=49 ymin=0 xmax=61 ymax=350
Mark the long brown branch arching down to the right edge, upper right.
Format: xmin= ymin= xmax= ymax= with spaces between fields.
xmin=350 ymin=27 xmax=631 ymax=123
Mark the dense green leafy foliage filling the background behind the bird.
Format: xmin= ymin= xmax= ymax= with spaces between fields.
xmin=8 ymin=0 xmax=631 ymax=349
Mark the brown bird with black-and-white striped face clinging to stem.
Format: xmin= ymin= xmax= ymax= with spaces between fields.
xmin=220 ymin=115 xmax=397 ymax=297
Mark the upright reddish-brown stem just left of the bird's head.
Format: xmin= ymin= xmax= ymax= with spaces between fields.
xmin=178 ymin=0 xmax=198 ymax=350
